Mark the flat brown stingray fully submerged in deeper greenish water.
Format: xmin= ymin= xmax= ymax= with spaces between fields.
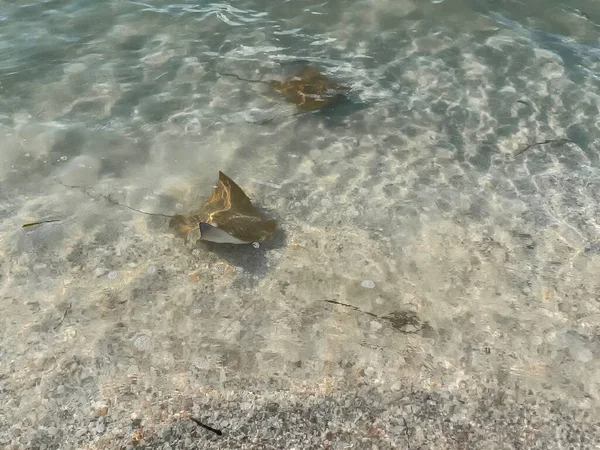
xmin=269 ymin=66 xmax=350 ymax=111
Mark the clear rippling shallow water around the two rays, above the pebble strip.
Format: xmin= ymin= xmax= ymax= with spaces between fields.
xmin=0 ymin=0 xmax=600 ymax=448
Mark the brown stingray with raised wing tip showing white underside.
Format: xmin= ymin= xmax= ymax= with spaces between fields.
xmin=169 ymin=171 xmax=277 ymax=244
